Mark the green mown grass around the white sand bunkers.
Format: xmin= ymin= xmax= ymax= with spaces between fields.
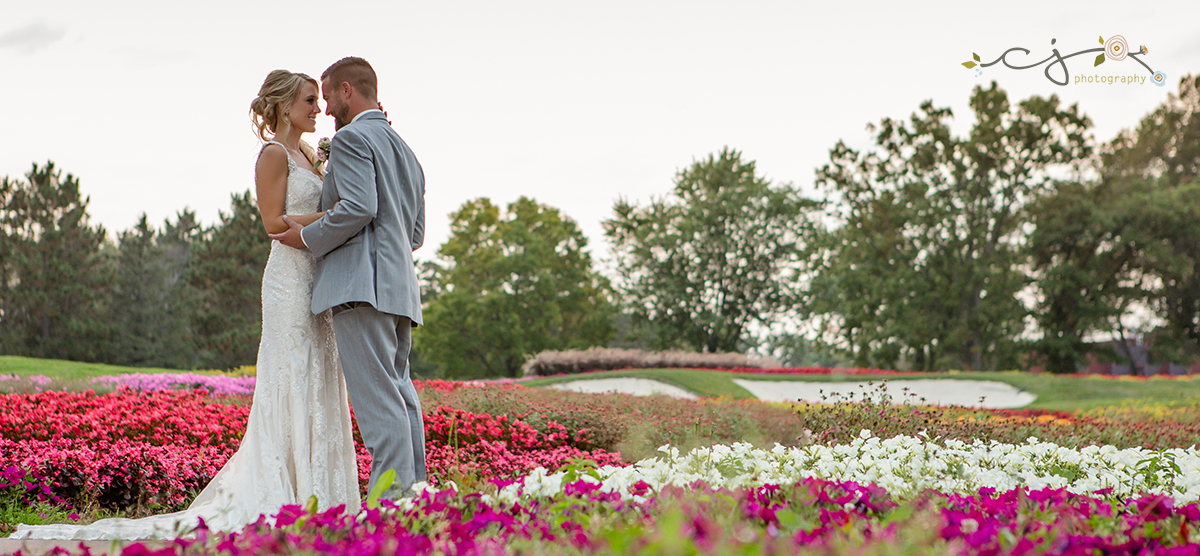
xmin=524 ymin=369 xmax=1200 ymax=411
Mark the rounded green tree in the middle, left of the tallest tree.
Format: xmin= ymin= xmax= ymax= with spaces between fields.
xmin=604 ymin=148 xmax=817 ymax=353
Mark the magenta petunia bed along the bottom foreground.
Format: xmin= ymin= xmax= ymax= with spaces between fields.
xmin=88 ymin=473 xmax=1200 ymax=555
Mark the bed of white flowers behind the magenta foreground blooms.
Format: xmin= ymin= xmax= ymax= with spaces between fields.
xmin=606 ymin=430 xmax=1200 ymax=503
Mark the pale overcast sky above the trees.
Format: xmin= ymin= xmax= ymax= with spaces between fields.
xmin=0 ymin=0 xmax=1200 ymax=264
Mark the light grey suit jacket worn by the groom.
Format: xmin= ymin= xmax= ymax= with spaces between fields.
xmin=300 ymin=112 xmax=425 ymax=325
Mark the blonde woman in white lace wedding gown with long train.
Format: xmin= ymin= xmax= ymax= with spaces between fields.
xmin=12 ymin=70 xmax=360 ymax=539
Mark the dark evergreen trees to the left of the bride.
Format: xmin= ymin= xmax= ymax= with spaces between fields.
xmin=0 ymin=168 xmax=270 ymax=369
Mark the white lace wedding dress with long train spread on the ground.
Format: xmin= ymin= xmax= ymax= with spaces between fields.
xmin=12 ymin=142 xmax=360 ymax=539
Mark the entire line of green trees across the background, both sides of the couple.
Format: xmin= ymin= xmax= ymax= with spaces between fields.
xmin=0 ymin=76 xmax=1200 ymax=377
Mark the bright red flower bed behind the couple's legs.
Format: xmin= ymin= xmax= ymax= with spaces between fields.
xmin=0 ymin=388 xmax=622 ymax=514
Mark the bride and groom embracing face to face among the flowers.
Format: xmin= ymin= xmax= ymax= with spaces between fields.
xmin=13 ymin=58 xmax=426 ymax=539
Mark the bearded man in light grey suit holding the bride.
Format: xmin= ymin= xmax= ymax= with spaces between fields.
xmin=271 ymin=56 xmax=425 ymax=498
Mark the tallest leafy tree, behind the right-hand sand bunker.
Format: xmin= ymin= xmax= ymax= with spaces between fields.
xmin=806 ymin=83 xmax=1091 ymax=370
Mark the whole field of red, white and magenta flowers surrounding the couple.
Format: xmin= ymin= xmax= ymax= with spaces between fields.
xmin=0 ymin=376 xmax=1200 ymax=555
